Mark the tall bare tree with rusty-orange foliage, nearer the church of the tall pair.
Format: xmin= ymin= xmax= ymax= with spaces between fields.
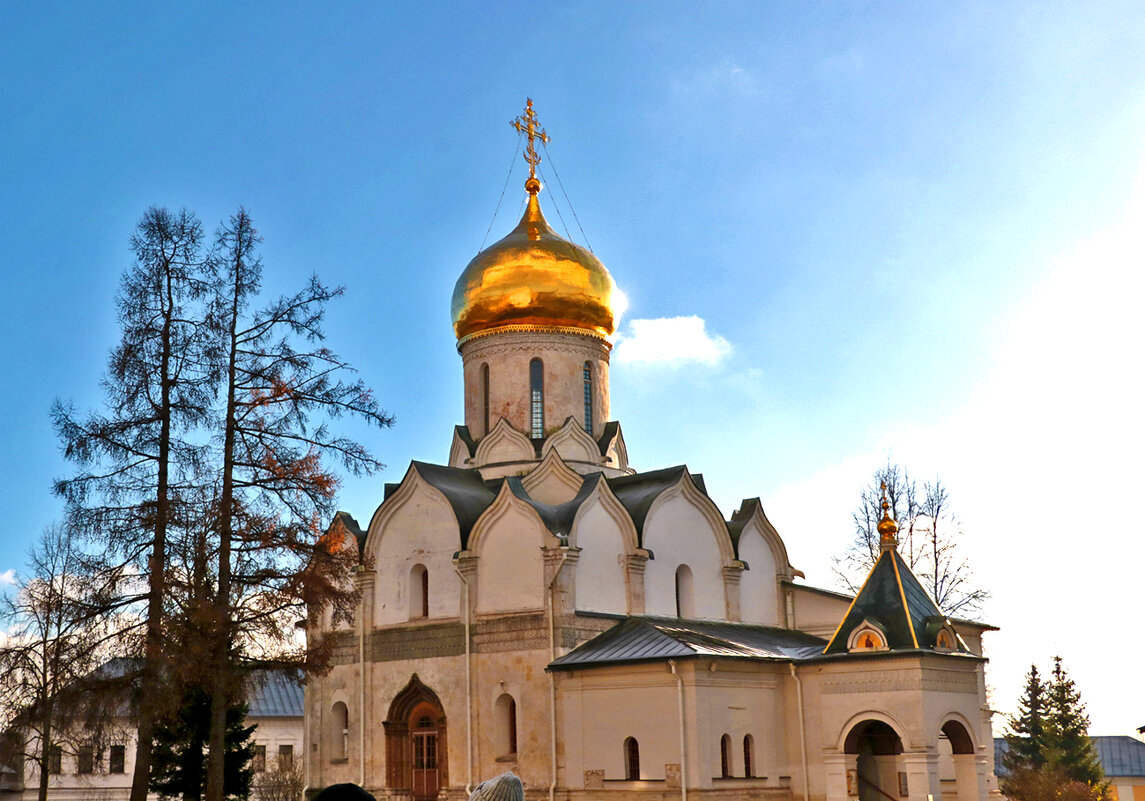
xmin=206 ymin=208 xmax=393 ymax=801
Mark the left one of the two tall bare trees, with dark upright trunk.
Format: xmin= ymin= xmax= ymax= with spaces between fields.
xmin=53 ymin=208 xmax=211 ymax=801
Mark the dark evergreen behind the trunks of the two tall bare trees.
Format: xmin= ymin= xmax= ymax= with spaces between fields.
xmin=151 ymin=684 xmax=254 ymax=801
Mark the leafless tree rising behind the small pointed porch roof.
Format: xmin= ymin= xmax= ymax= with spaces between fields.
xmin=834 ymin=461 xmax=989 ymax=616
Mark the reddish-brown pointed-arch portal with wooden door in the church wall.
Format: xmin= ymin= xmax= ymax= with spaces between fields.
xmin=382 ymin=674 xmax=449 ymax=801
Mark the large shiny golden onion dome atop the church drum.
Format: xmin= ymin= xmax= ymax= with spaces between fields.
xmin=452 ymin=193 xmax=617 ymax=340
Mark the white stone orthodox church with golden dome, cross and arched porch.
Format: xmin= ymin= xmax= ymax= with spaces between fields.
xmin=303 ymin=102 xmax=1001 ymax=801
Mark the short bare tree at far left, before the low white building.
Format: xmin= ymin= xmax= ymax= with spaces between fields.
xmin=0 ymin=525 xmax=118 ymax=801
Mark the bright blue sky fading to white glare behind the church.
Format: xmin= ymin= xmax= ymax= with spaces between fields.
xmin=0 ymin=2 xmax=1145 ymax=733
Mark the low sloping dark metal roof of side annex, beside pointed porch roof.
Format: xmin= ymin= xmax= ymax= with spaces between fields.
xmin=548 ymin=616 xmax=824 ymax=671
